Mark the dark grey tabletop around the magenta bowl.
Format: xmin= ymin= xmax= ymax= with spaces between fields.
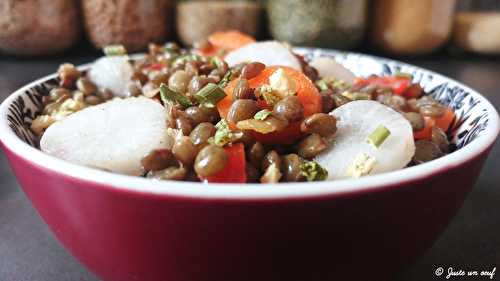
xmin=0 ymin=48 xmax=500 ymax=281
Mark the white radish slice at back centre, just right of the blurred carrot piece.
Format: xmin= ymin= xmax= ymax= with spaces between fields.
xmin=224 ymin=41 xmax=302 ymax=71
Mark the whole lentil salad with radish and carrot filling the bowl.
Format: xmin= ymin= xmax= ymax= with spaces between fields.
xmin=31 ymin=31 xmax=455 ymax=183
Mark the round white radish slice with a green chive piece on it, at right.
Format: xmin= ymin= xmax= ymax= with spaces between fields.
xmin=315 ymin=101 xmax=415 ymax=180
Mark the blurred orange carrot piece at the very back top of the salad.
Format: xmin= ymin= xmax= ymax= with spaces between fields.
xmin=200 ymin=30 xmax=255 ymax=56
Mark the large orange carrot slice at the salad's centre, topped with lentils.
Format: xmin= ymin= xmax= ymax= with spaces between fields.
xmin=217 ymin=66 xmax=322 ymax=144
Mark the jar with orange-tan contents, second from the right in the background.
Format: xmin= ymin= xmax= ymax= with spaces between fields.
xmin=371 ymin=0 xmax=456 ymax=55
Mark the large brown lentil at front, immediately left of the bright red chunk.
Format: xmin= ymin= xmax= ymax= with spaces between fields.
xmin=194 ymin=144 xmax=227 ymax=177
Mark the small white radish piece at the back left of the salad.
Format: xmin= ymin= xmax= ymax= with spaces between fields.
xmin=88 ymin=56 xmax=134 ymax=97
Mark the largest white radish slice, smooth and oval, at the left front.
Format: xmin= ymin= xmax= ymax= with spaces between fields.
xmin=40 ymin=97 xmax=168 ymax=176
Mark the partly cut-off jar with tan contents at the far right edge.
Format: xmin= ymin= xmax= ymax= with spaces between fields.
xmin=453 ymin=0 xmax=500 ymax=54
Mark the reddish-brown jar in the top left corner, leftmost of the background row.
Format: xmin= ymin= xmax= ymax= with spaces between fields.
xmin=0 ymin=0 xmax=81 ymax=55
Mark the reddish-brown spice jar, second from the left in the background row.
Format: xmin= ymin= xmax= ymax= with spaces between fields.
xmin=82 ymin=0 xmax=174 ymax=51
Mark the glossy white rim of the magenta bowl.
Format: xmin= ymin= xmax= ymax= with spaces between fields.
xmin=0 ymin=50 xmax=500 ymax=200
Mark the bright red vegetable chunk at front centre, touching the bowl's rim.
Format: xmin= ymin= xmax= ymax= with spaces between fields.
xmin=201 ymin=143 xmax=247 ymax=183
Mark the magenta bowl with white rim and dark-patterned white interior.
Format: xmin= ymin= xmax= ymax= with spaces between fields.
xmin=0 ymin=48 xmax=499 ymax=281
